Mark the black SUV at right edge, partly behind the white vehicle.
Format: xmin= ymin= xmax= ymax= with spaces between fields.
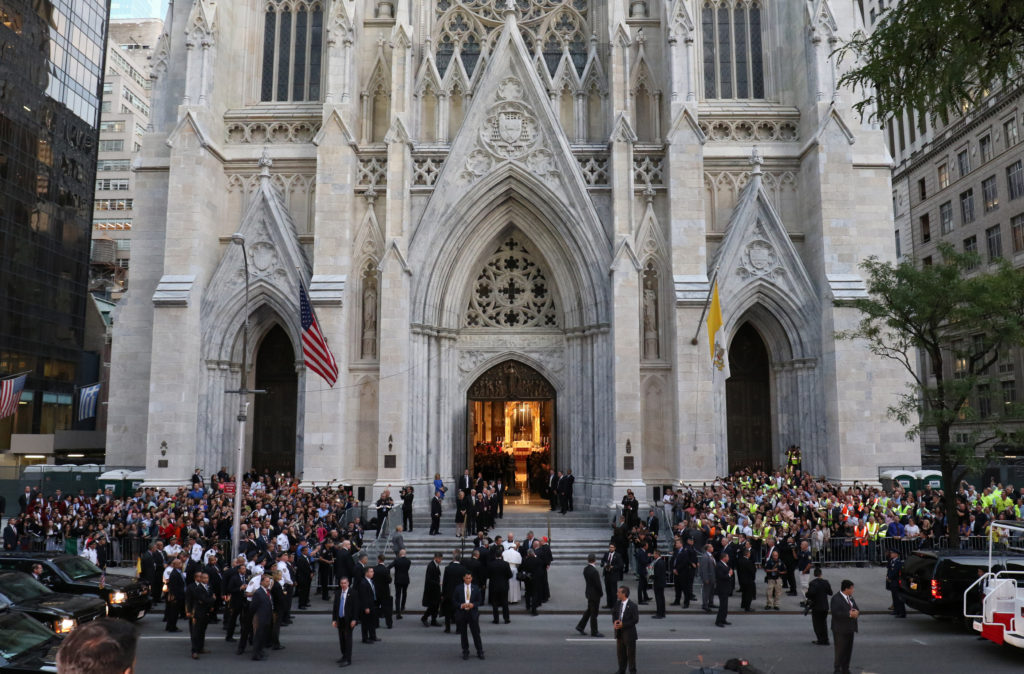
xmin=899 ymin=550 xmax=1024 ymax=619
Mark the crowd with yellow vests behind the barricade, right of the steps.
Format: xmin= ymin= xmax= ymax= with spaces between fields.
xmin=611 ymin=448 xmax=1024 ymax=587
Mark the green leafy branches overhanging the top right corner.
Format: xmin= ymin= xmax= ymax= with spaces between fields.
xmin=837 ymin=0 xmax=1024 ymax=124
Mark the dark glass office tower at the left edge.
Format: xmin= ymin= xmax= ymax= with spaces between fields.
xmin=0 ymin=0 xmax=109 ymax=450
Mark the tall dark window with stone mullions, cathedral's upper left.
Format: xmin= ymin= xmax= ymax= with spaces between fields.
xmin=260 ymin=0 xmax=324 ymax=101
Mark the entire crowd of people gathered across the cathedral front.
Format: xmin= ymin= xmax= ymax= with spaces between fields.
xmin=6 ymin=462 xmax=1024 ymax=664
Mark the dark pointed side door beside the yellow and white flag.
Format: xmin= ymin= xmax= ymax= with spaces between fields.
xmin=725 ymin=323 xmax=772 ymax=472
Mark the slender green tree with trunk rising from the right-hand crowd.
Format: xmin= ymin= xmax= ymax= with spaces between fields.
xmin=838 ymin=244 xmax=1024 ymax=547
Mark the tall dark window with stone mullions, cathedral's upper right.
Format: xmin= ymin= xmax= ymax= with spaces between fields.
xmin=700 ymin=0 xmax=765 ymax=98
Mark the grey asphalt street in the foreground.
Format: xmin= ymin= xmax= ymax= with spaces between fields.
xmin=136 ymin=613 xmax=1024 ymax=674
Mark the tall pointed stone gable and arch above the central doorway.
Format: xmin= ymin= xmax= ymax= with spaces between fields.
xmin=410 ymin=7 xmax=611 ymax=329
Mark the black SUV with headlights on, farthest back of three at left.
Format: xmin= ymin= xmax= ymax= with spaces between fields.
xmin=0 ymin=552 xmax=152 ymax=621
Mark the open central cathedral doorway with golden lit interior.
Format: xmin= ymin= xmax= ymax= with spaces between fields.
xmin=466 ymin=360 xmax=556 ymax=493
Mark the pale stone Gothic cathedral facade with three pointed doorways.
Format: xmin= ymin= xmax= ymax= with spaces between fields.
xmin=108 ymin=0 xmax=920 ymax=506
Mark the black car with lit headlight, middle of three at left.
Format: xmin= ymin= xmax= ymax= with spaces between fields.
xmin=0 ymin=571 xmax=106 ymax=635
